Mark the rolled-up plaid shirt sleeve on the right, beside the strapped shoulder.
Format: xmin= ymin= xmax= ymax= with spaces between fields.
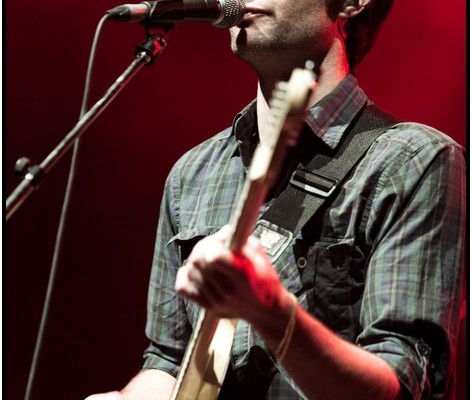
xmin=358 ymin=124 xmax=465 ymax=399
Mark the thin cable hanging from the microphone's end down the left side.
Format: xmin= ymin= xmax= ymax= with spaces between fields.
xmin=25 ymin=15 xmax=108 ymax=400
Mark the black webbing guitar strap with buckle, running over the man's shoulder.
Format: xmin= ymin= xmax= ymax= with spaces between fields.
xmin=254 ymin=105 xmax=401 ymax=262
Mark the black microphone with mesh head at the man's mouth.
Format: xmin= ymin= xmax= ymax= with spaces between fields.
xmin=105 ymin=0 xmax=246 ymax=28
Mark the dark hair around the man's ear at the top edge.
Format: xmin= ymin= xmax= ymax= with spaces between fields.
xmin=324 ymin=0 xmax=393 ymax=70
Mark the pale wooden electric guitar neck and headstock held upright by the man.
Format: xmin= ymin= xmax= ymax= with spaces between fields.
xmin=171 ymin=68 xmax=314 ymax=400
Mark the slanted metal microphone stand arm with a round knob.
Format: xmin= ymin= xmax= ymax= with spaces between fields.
xmin=6 ymin=29 xmax=169 ymax=221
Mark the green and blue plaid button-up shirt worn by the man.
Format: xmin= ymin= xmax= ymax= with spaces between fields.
xmin=144 ymin=75 xmax=465 ymax=399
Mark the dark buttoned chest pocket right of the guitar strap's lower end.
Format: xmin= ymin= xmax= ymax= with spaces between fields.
xmin=294 ymin=238 xmax=366 ymax=342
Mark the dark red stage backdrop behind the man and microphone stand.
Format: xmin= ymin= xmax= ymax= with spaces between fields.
xmin=3 ymin=0 xmax=467 ymax=400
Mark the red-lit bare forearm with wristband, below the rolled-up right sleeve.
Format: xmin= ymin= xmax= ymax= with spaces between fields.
xmin=253 ymin=296 xmax=401 ymax=400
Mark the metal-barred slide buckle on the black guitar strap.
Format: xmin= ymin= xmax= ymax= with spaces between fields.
xmin=290 ymin=167 xmax=339 ymax=198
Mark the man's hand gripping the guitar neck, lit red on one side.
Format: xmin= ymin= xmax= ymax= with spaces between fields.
xmin=175 ymin=226 xmax=285 ymax=322
